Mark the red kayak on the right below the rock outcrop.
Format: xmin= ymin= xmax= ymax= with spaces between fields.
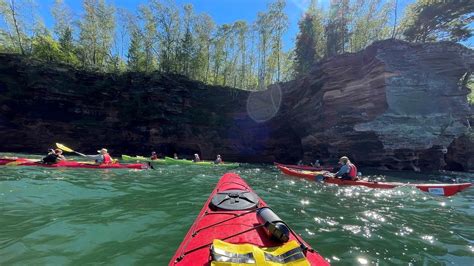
xmin=277 ymin=165 xmax=472 ymax=196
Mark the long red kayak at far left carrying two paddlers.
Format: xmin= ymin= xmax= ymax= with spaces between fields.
xmin=0 ymin=158 xmax=148 ymax=169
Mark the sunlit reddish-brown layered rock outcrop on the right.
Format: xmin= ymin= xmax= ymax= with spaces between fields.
xmin=284 ymin=40 xmax=474 ymax=170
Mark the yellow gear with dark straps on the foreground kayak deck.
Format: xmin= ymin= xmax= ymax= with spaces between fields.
xmin=211 ymin=239 xmax=311 ymax=266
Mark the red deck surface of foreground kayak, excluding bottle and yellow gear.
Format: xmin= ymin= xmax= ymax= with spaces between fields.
xmin=169 ymin=173 xmax=329 ymax=265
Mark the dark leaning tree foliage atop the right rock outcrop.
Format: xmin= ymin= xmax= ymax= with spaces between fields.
xmin=401 ymin=0 xmax=474 ymax=42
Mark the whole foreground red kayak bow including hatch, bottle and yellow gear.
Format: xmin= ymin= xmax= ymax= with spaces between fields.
xmin=169 ymin=173 xmax=329 ymax=265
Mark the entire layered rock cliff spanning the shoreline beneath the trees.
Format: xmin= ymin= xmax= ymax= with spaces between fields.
xmin=0 ymin=40 xmax=474 ymax=171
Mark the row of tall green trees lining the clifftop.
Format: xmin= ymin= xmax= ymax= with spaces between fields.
xmin=0 ymin=0 xmax=474 ymax=93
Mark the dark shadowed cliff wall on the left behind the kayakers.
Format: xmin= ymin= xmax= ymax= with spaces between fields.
xmin=0 ymin=55 xmax=301 ymax=162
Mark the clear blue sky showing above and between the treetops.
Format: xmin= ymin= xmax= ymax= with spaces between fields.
xmin=37 ymin=0 xmax=473 ymax=50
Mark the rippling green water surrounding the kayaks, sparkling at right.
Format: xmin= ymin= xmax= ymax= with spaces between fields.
xmin=0 ymin=159 xmax=474 ymax=265
